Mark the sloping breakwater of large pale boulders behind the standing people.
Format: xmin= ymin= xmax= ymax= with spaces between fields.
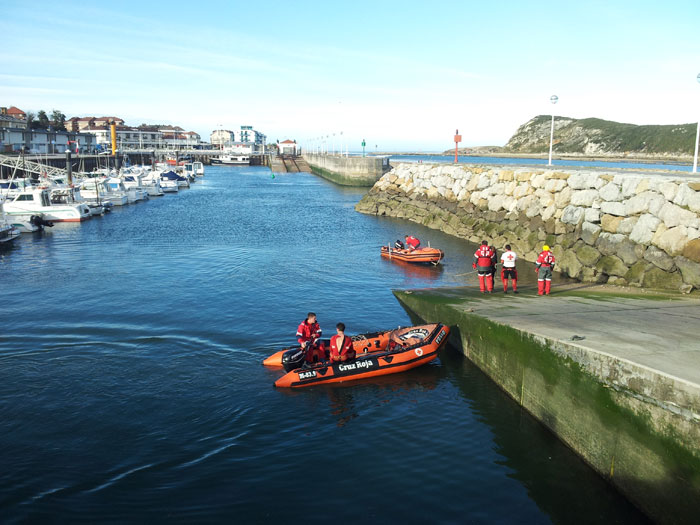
xmin=356 ymin=163 xmax=700 ymax=293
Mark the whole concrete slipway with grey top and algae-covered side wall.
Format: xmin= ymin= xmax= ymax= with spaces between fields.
xmin=394 ymin=284 xmax=700 ymax=523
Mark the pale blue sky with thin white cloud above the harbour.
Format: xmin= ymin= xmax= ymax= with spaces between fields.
xmin=0 ymin=0 xmax=700 ymax=152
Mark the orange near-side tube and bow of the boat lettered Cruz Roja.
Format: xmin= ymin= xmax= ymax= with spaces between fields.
xmin=274 ymin=323 xmax=450 ymax=388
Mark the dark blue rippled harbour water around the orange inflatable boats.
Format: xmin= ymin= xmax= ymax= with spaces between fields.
xmin=0 ymin=167 xmax=643 ymax=523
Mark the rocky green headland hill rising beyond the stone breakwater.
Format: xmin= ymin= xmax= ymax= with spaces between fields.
xmin=503 ymin=115 xmax=697 ymax=156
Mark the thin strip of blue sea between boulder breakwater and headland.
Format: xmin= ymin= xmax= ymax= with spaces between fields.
xmin=391 ymin=155 xmax=693 ymax=172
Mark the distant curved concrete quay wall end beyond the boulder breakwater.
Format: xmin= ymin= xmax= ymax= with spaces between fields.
xmin=303 ymin=153 xmax=388 ymax=186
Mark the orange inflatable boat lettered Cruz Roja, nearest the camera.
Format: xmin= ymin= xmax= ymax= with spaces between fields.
xmin=263 ymin=323 xmax=450 ymax=388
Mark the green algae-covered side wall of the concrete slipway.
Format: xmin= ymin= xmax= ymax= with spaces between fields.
xmin=394 ymin=291 xmax=700 ymax=523
